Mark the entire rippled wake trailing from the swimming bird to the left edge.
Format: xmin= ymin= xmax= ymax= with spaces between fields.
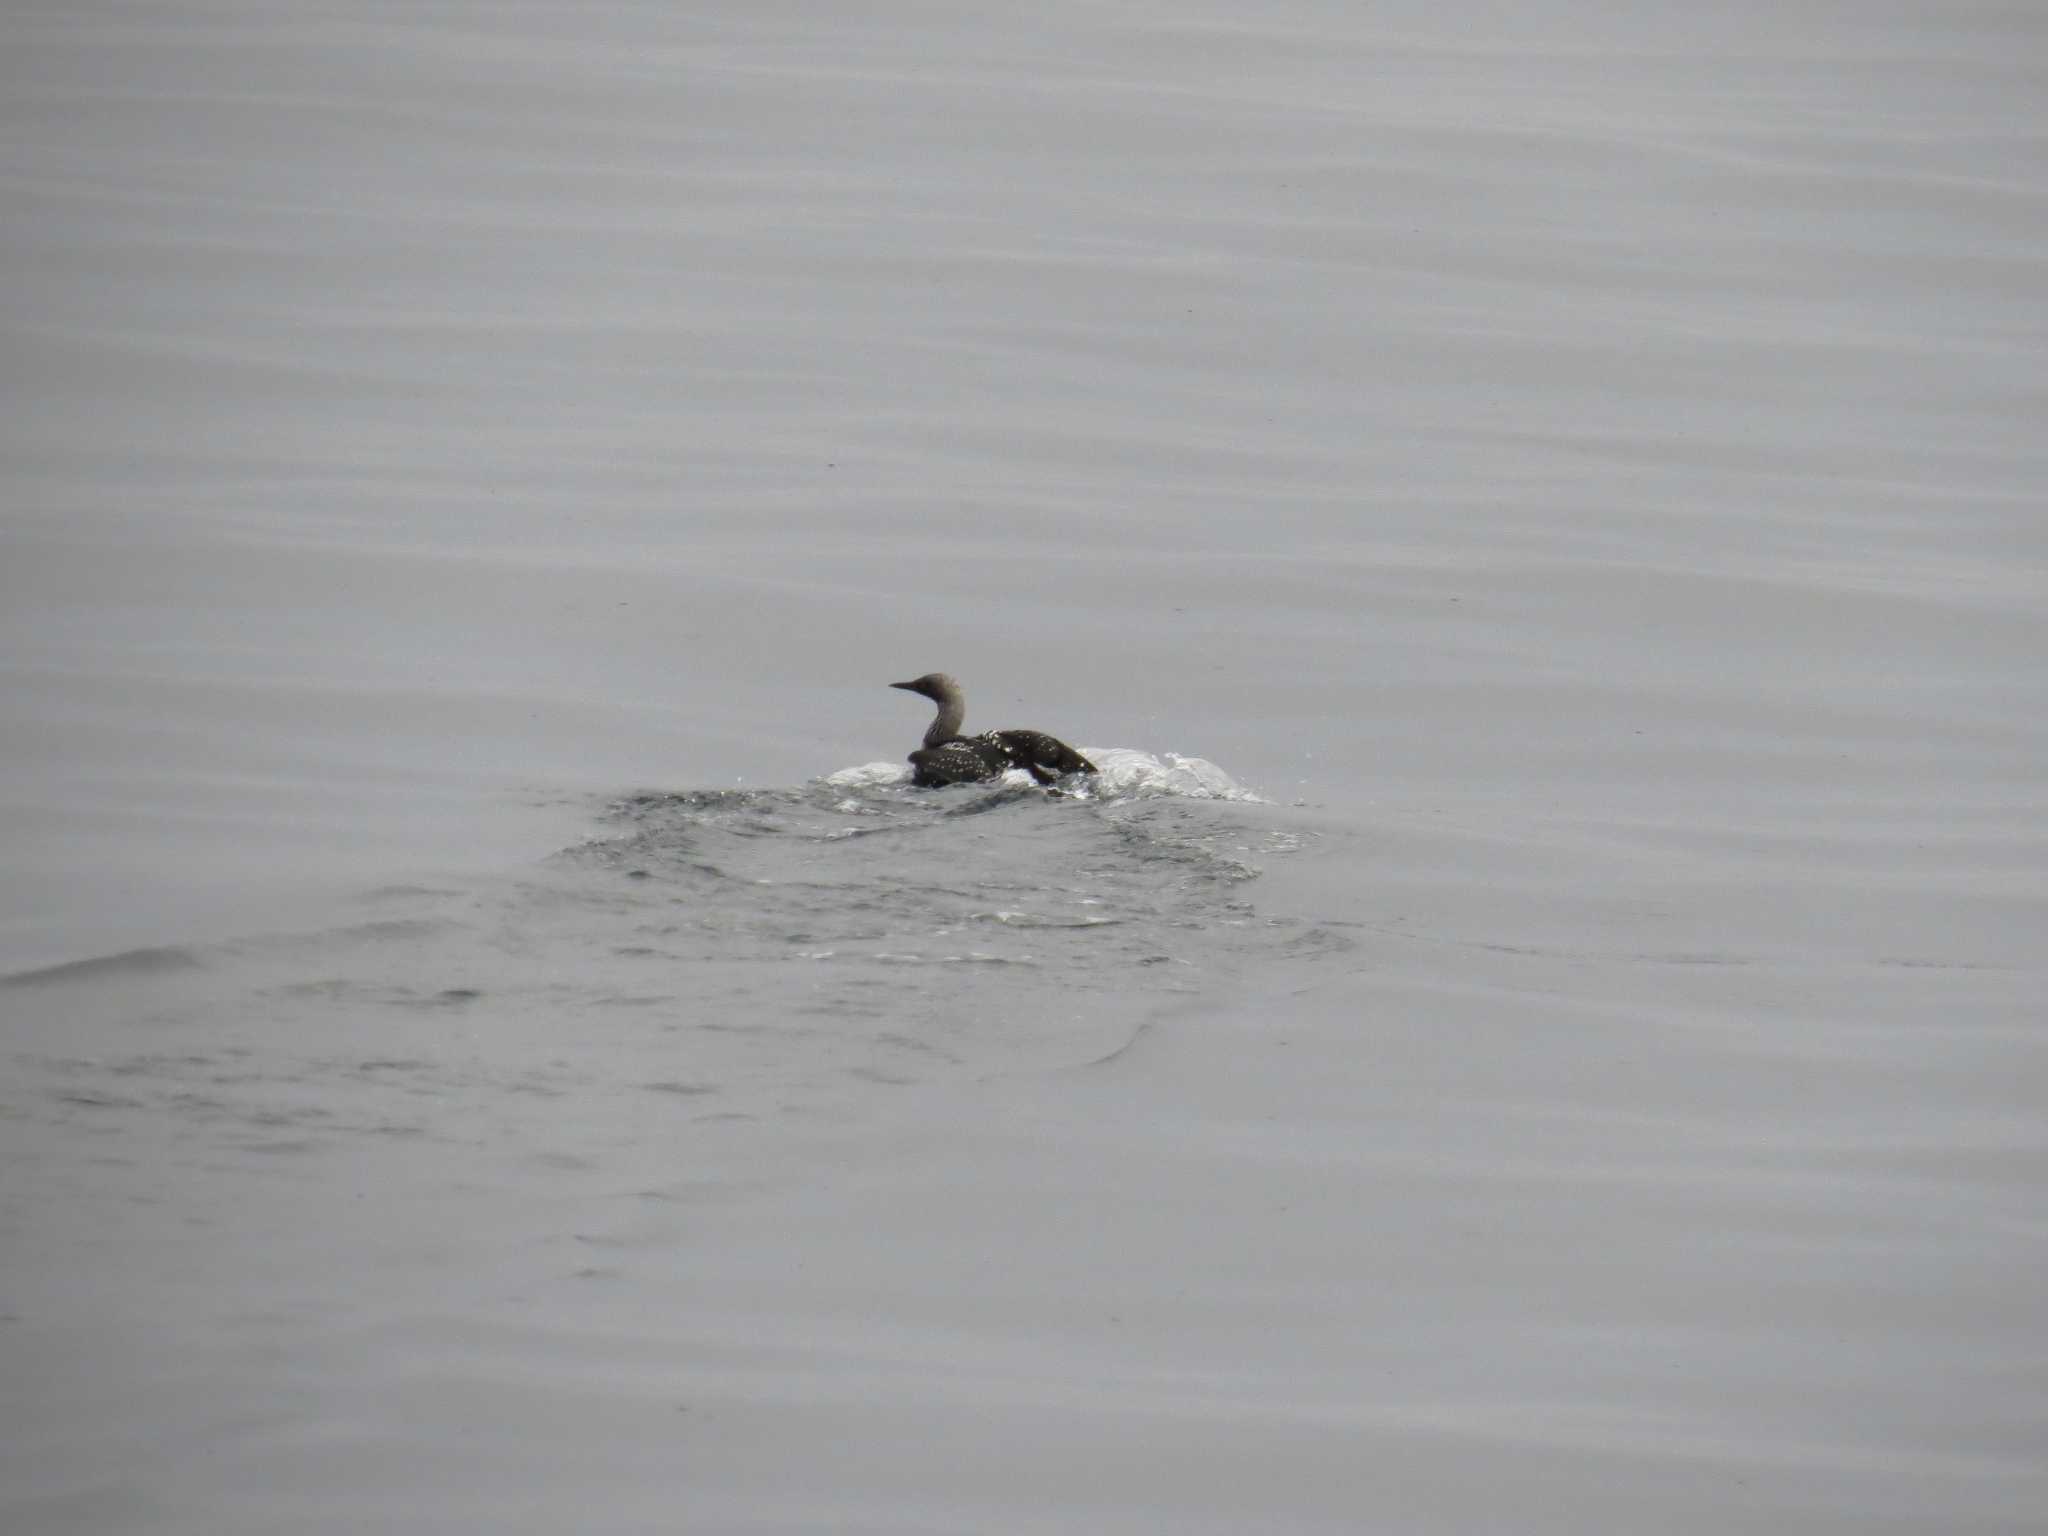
xmin=0 ymin=750 xmax=1346 ymax=1155
